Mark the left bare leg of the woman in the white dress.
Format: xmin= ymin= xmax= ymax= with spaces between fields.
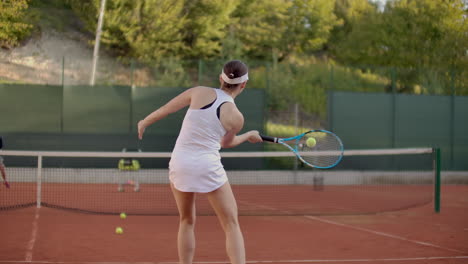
xmin=171 ymin=184 xmax=195 ymax=264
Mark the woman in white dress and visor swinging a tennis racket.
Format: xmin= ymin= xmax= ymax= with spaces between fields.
xmin=138 ymin=60 xmax=262 ymax=264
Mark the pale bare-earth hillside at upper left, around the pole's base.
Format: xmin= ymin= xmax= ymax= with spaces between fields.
xmin=0 ymin=3 xmax=119 ymax=84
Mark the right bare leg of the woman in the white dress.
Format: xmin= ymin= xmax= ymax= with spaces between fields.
xmin=208 ymin=182 xmax=245 ymax=264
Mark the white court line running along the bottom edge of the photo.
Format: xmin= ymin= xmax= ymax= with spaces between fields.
xmin=0 ymin=256 xmax=468 ymax=264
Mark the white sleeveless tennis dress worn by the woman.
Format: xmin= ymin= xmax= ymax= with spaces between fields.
xmin=169 ymin=89 xmax=234 ymax=193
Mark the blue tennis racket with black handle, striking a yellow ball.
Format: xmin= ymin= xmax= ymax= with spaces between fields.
xmin=260 ymin=129 xmax=344 ymax=169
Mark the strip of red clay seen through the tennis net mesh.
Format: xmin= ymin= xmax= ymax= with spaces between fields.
xmin=0 ymin=183 xmax=434 ymax=215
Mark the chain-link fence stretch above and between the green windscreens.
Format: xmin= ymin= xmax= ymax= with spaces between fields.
xmin=0 ymin=55 xmax=468 ymax=136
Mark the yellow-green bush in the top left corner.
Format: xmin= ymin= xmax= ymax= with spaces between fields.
xmin=0 ymin=0 xmax=33 ymax=49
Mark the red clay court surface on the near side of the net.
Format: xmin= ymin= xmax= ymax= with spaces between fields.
xmin=0 ymin=185 xmax=468 ymax=264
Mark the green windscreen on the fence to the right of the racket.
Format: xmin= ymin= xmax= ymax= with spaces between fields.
xmin=328 ymin=91 xmax=468 ymax=170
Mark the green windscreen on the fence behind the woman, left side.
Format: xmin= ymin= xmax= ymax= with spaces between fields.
xmin=0 ymin=84 xmax=265 ymax=154
